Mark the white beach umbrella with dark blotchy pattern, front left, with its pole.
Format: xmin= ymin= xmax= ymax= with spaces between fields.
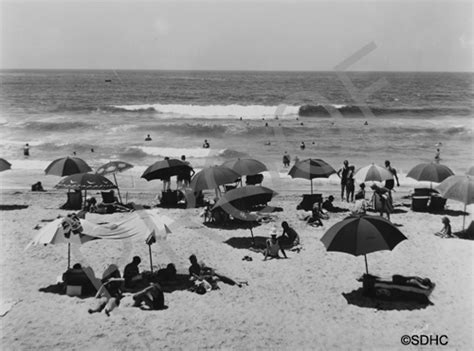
xmin=26 ymin=216 xmax=98 ymax=268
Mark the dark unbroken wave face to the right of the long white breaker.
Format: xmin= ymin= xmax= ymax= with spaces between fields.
xmin=298 ymin=105 xmax=472 ymax=117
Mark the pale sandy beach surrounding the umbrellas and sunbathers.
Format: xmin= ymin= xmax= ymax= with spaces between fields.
xmin=0 ymin=171 xmax=474 ymax=350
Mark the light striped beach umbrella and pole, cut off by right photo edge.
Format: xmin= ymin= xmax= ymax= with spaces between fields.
xmin=435 ymin=174 xmax=474 ymax=230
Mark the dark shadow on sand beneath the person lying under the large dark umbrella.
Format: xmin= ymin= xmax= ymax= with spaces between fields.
xmin=342 ymin=288 xmax=433 ymax=311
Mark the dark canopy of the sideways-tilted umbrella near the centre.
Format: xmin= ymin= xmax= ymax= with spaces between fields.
xmin=212 ymin=186 xmax=276 ymax=211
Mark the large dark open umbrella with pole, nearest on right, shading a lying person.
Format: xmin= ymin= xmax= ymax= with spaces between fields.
xmin=321 ymin=216 xmax=406 ymax=274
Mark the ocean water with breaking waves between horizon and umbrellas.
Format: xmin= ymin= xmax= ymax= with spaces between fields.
xmin=0 ymin=70 xmax=474 ymax=179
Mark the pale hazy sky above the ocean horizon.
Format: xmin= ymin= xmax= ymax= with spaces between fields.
xmin=0 ymin=0 xmax=473 ymax=71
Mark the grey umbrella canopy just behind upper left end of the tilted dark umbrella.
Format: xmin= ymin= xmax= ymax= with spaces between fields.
xmin=191 ymin=166 xmax=239 ymax=192
